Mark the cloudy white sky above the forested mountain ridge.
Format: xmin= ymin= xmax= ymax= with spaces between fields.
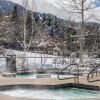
xmin=6 ymin=0 xmax=100 ymax=23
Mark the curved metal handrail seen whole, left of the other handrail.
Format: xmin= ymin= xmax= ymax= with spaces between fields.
xmin=58 ymin=63 xmax=79 ymax=82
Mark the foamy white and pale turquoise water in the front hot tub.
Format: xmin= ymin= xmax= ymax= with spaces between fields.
xmin=0 ymin=87 xmax=100 ymax=100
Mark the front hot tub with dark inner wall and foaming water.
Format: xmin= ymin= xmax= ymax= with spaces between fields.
xmin=0 ymin=84 xmax=100 ymax=100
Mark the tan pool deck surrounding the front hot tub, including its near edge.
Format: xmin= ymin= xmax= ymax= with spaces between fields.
xmin=0 ymin=75 xmax=100 ymax=100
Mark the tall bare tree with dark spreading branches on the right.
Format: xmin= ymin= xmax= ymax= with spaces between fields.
xmin=58 ymin=0 xmax=95 ymax=63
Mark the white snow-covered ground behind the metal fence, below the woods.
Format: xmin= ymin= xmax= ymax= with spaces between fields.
xmin=0 ymin=49 xmax=100 ymax=71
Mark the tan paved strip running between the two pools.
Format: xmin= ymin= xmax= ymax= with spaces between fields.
xmin=0 ymin=76 xmax=100 ymax=87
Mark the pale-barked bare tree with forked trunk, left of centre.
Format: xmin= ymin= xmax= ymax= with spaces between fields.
xmin=15 ymin=0 xmax=35 ymax=70
